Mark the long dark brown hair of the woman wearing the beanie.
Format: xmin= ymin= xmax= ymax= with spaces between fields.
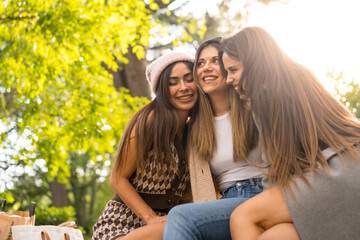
xmin=112 ymin=61 xmax=194 ymax=180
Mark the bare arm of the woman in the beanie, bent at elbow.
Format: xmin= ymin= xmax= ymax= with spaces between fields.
xmin=110 ymin=127 xmax=166 ymax=224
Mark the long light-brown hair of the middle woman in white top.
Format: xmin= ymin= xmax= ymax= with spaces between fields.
xmin=190 ymin=38 xmax=257 ymax=161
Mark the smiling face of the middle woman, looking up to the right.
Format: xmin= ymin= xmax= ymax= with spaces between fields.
xmin=195 ymin=45 xmax=228 ymax=95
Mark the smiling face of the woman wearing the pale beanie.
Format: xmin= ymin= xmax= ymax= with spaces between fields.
xmin=168 ymin=62 xmax=198 ymax=112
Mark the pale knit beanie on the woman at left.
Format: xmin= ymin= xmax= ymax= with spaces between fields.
xmin=145 ymin=51 xmax=195 ymax=93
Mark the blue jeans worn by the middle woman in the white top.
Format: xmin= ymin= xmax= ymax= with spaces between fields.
xmin=163 ymin=179 xmax=263 ymax=240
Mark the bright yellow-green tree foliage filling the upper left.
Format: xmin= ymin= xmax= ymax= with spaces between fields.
xmin=0 ymin=0 xmax=152 ymax=182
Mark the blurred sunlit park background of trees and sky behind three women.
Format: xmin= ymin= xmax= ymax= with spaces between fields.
xmin=0 ymin=0 xmax=360 ymax=239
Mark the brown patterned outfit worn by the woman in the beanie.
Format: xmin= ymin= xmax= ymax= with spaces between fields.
xmin=92 ymin=137 xmax=191 ymax=240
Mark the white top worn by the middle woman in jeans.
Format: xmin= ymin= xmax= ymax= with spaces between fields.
xmin=210 ymin=112 xmax=263 ymax=192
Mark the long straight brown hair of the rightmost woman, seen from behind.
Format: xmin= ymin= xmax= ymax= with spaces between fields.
xmin=221 ymin=27 xmax=360 ymax=192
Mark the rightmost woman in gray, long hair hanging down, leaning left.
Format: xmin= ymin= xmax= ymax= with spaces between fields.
xmin=221 ymin=27 xmax=360 ymax=240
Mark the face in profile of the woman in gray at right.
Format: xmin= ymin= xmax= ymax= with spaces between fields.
xmin=222 ymin=52 xmax=246 ymax=95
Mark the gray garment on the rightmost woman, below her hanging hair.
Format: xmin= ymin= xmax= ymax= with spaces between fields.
xmin=286 ymin=147 xmax=360 ymax=240
